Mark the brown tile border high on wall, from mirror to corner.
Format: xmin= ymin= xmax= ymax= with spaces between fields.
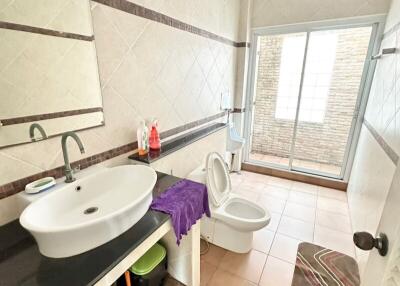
xmin=92 ymin=0 xmax=249 ymax=48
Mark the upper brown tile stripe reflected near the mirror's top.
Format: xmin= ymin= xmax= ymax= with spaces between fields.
xmin=0 ymin=21 xmax=94 ymax=42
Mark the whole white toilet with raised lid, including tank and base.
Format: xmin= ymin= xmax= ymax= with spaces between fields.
xmin=188 ymin=152 xmax=271 ymax=253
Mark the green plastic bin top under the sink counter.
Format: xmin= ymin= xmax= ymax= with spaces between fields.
xmin=130 ymin=243 xmax=167 ymax=276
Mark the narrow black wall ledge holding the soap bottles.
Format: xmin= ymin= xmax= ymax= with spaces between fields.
xmin=128 ymin=123 xmax=227 ymax=164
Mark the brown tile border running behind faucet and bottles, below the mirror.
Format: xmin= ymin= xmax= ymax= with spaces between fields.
xmin=0 ymin=112 xmax=225 ymax=199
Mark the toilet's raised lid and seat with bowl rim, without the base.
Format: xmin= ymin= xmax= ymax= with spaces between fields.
xmin=206 ymin=152 xmax=270 ymax=231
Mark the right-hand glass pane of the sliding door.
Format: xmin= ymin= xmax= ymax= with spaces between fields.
xmin=291 ymin=27 xmax=372 ymax=177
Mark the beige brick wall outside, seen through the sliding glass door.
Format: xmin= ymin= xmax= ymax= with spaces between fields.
xmin=252 ymin=28 xmax=370 ymax=166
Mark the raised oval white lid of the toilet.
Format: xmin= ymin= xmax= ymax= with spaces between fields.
xmin=206 ymin=152 xmax=231 ymax=207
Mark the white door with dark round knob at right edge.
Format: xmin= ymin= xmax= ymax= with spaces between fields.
xmin=361 ymin=164 xmax=400 ymax=286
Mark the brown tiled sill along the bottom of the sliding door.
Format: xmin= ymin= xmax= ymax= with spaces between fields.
xmin=242 ymin=163 xmax=347 ymax=192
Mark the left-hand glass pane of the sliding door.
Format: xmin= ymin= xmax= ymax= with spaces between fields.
xmin=249 ymin=33 xmax=307 ymax=168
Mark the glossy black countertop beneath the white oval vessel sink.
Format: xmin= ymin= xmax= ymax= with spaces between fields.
xmin=0 ymin=173 xmax=180 ymax=286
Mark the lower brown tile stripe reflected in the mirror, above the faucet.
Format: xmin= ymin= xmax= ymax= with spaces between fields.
xmin=0 ymin=107 xmax=103 ymax=126
